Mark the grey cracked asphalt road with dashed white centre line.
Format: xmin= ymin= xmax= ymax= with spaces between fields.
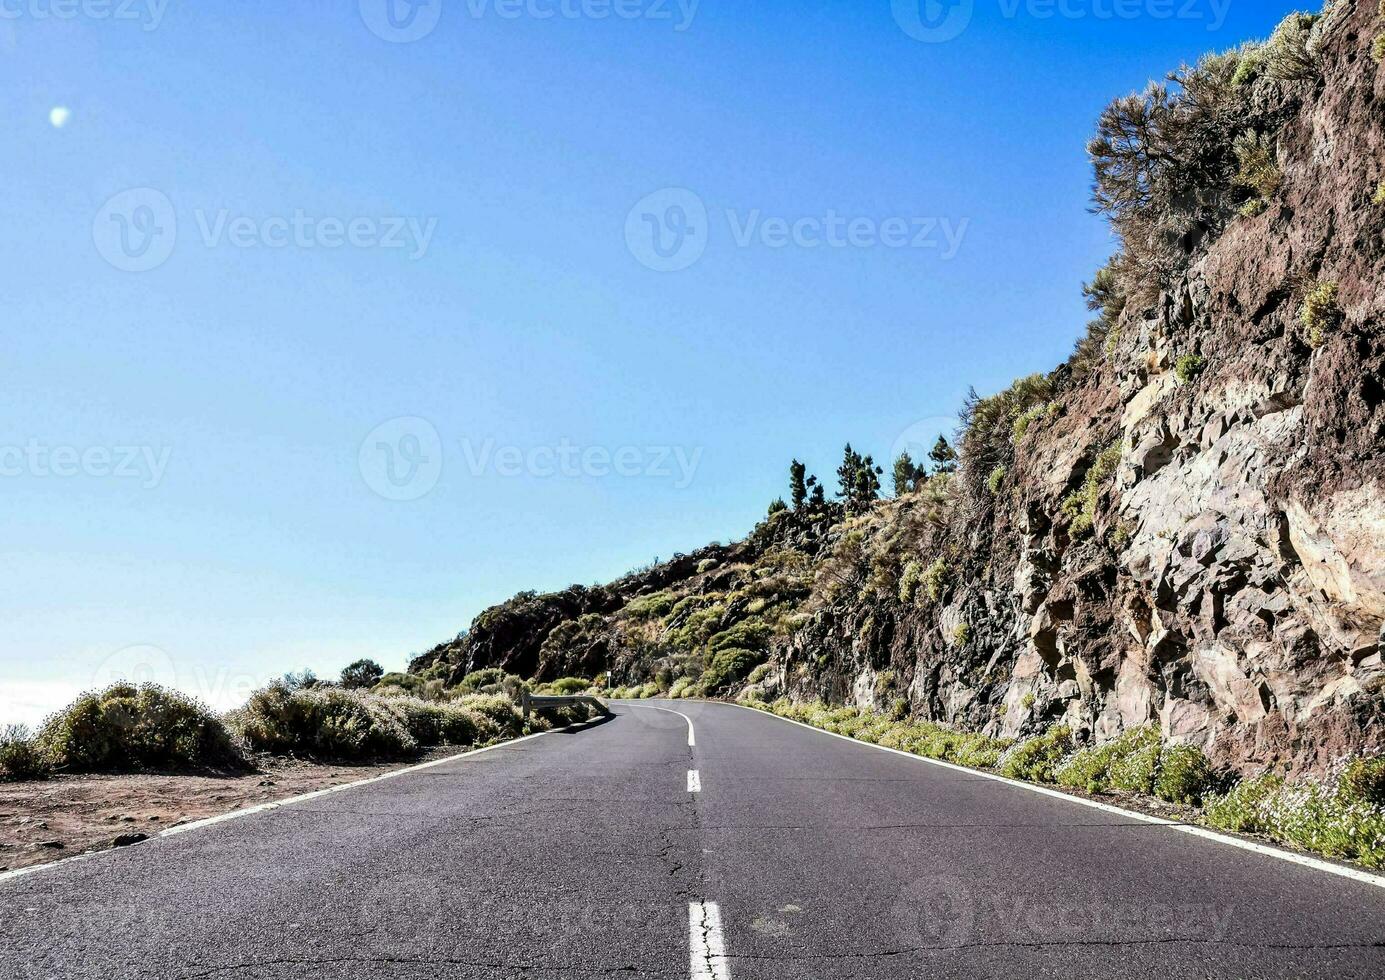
xmin=0 ymin=702 xmax=1385 ymax=980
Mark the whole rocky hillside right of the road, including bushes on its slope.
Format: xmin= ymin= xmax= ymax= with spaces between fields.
xmin=413 ymin=0 xmax=1385 ymax=774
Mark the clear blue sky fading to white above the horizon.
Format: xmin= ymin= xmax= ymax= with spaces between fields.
xmin=0 ymin=0 xmax=1292 ymax=723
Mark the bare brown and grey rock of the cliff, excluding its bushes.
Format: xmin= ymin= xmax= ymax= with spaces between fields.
xmin=425 ymin=0 xmax=1385 ymax=774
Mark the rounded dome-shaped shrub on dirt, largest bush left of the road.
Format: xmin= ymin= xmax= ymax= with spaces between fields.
xmin=37 ymin=682 xmax=242 ymax=772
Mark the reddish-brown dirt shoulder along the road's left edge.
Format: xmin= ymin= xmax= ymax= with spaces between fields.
xmin=0 ymin=747 xmax=463 ymax=872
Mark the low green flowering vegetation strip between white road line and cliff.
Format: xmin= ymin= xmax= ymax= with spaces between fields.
xmin=740 ymin=698 xmax=1385 ymax=868
